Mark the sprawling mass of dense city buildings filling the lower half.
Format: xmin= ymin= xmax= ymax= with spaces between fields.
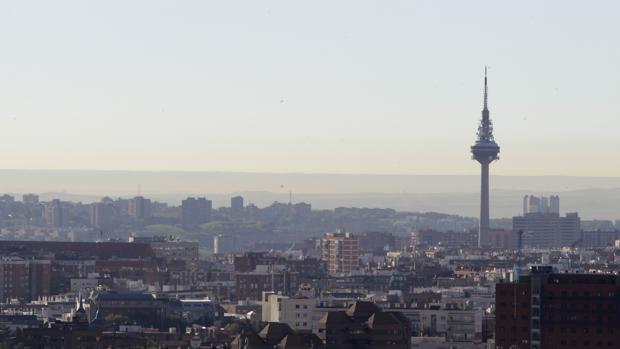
xmin=0 ymin=190 xmax=620 ymax=349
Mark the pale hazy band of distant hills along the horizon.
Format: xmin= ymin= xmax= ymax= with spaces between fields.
xmin=0 ymin=170 xmax=620 ymax=219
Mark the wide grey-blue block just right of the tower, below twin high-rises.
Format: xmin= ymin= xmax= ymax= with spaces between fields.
xmin=512 ymin=212 xmax=581 ymax=248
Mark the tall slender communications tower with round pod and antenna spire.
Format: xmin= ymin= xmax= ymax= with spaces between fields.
xmin=471 ymin=67 xmax=499 ymax=247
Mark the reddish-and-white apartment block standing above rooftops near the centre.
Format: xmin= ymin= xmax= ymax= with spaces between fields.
xmin=321 ymin=231 xmax=360 ymax=274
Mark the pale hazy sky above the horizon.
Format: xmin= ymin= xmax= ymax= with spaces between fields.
xmin=0 ymin=0 xmax=620 ymax=176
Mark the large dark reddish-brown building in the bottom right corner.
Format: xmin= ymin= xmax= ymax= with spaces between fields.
xmin=495 ymin=267 xmax=620 ymax=349
